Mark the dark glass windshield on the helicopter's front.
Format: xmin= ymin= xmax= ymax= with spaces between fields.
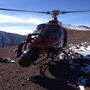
xmin=40 ymin=25 xmax=61 ymax=40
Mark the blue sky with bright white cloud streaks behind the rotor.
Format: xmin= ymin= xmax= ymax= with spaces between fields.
xmin=0 ymin=0 xmax=90 ymax=34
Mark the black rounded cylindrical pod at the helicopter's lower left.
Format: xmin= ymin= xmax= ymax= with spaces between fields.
xmin=18 ymin=48 xmax=39 ymax=67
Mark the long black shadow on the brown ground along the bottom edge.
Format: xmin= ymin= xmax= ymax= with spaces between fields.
xmin=31 ymin=75 xmax=79 ymax=90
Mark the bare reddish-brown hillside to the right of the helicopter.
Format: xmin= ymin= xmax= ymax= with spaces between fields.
xmin=66 ymin=29 xmax=90 ymax=44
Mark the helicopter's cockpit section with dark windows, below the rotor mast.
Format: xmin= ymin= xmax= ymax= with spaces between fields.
xmin=37 ymin=24 xmax=61 ymax=41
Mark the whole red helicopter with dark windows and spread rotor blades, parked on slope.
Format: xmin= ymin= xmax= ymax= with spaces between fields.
xmin=0 ymin=8 xmax=90 ymax=67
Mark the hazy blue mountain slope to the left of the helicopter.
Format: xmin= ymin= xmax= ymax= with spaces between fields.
xmin=0 ymin=31 xmax=25 ymax=48
